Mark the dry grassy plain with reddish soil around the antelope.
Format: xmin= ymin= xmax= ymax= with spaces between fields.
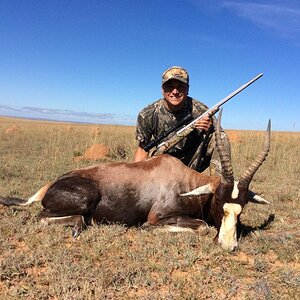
xmin=0 ymin=117 xmax=300 ymax=299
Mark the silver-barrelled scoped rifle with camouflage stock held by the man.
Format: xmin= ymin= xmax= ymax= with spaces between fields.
xmin=150 ymin=73 xmax=263 ymax=155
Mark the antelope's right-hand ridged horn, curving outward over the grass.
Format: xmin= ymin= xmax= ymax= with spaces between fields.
xmin=239 ymin=120 xmax=271 ymax=187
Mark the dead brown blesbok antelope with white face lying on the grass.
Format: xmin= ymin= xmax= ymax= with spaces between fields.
xmin=0 ymin=116 xmax=270 ymax=251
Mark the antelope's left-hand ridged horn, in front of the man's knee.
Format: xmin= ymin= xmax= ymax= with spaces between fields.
xmin=215 ymin=109 xmax=234 ymax=184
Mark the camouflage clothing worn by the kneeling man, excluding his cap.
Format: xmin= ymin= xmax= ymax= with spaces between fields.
xmin=136 ymin=97 xmax=220 ymax=172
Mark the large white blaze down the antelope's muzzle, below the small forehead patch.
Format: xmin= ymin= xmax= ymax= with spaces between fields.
xmin=218 ymin=203 xmax=242 ymax=251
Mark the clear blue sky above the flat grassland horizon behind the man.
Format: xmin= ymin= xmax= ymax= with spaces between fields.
xmin=0 ymin=0 xmax=300 ymax=131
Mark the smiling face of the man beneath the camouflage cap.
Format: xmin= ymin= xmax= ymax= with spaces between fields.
xmin=162 ymin=79 xmax=189 ymax=109
